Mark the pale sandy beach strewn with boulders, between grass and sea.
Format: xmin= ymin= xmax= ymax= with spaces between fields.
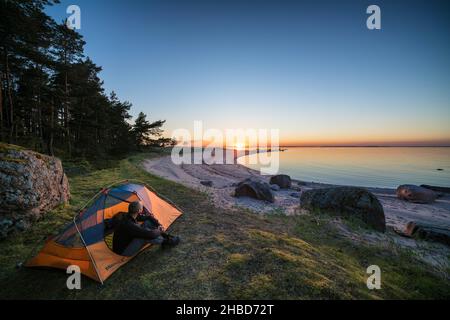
xmin=143 ymin=156 xmax=450 ymax=272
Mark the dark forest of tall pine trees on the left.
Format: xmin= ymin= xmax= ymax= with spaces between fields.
xmin=0 ymin=0 xmax=171 ymax=159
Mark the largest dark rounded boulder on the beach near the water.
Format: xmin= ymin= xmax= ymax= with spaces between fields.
xmin=300 ymin=187 xmax=386 ymax=232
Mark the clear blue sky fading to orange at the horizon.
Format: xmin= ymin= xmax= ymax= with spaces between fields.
xmin=47 ymin=0 xmax=450 ymax=145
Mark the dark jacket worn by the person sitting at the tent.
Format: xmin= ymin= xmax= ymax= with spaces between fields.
xmin=113 ymin=214 xmax=161 ymax=254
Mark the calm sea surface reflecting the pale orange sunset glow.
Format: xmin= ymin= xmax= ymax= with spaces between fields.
xmin=238 ymin=147 xmax=450 ymax=188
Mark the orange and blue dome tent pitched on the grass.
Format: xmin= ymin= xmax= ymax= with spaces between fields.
xmin=25 ymin=181 xmax=182 ymax=283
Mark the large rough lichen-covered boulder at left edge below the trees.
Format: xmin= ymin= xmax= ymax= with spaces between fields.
xmin=0 ymin=144 xmax=70 ymax=239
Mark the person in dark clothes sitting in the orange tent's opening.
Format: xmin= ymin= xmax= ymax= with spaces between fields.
xmin=113 ymin=201 xmax=180 ymax=256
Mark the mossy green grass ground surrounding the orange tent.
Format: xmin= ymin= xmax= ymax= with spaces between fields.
xmin=0 ymin=153 xmax=450 ymax=299
